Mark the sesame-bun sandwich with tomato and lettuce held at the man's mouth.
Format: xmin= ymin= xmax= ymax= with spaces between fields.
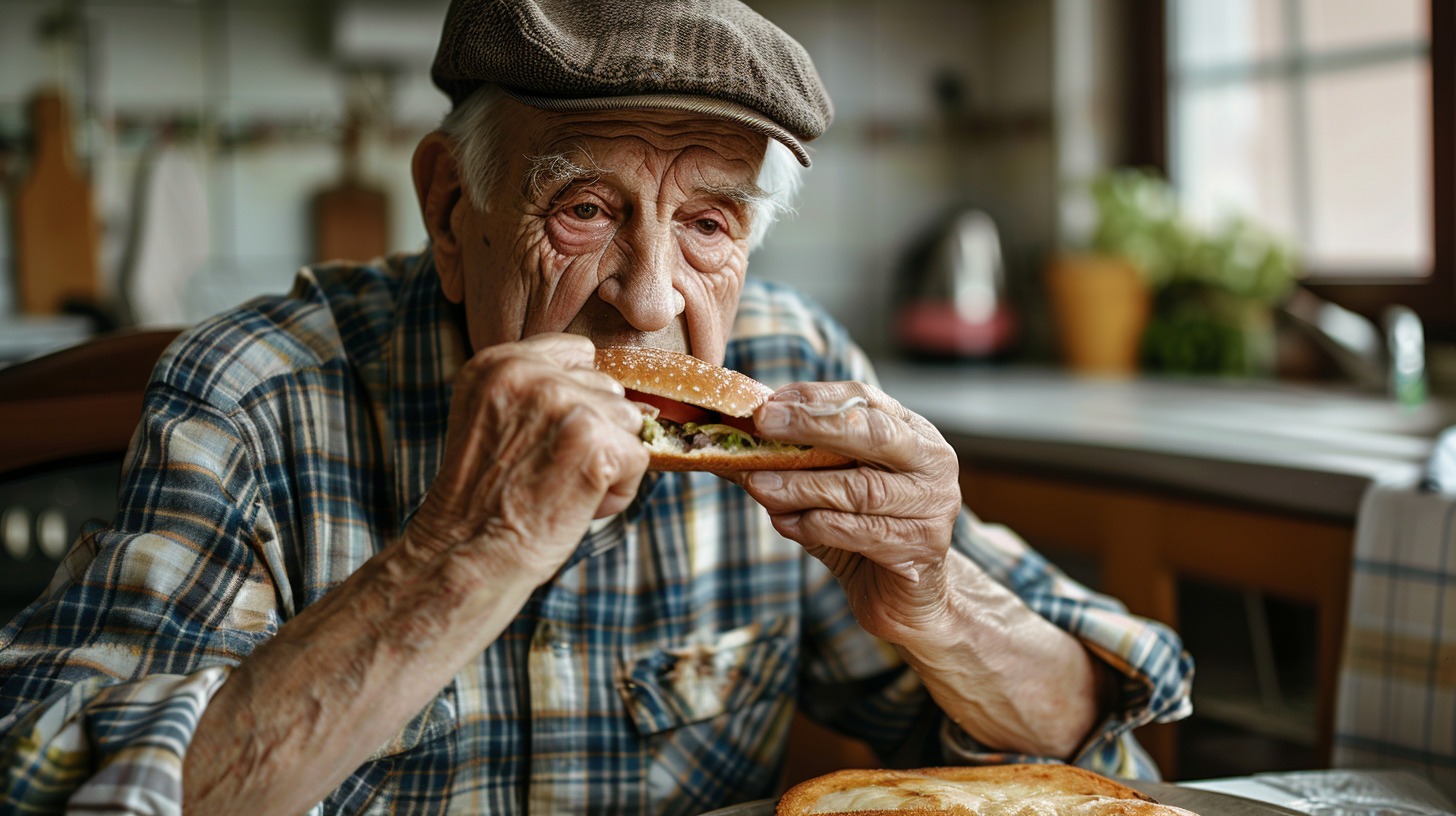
xmin=596 ymin=347 xmax=852 ymax=472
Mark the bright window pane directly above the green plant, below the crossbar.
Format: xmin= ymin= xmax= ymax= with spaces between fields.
xmin=1174 ymin=82 xmax=1296 ymax=242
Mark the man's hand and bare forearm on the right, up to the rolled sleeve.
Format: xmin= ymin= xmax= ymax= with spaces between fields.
xmin=731 ymin=382 xmax=1102 ymax=759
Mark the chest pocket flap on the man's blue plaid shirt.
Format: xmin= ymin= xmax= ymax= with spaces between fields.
xmin=617 ymin=618 xmax=798 ymax=736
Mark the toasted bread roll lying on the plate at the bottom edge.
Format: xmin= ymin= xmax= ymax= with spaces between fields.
xmin=775 ymin=765 xmax=1197 ymax=816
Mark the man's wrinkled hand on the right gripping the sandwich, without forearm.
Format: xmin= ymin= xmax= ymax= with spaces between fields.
xmin=729 ymin=382 xmax=961 ymax=643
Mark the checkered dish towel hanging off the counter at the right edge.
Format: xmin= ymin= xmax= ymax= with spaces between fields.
xmin=1334 ymin=430 xmax=1456 ymax=799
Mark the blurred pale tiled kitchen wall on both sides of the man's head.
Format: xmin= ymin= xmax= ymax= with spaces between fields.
xmin=0 ymin=0 xmax=1059 ymax=358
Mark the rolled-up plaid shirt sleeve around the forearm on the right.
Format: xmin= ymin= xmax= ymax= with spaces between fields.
xmin=799 ymin=507 xmax=1192 ymax=780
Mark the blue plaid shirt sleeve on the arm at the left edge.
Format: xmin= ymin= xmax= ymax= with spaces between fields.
xmin=0 ymin=383 xmax=278 ymax=813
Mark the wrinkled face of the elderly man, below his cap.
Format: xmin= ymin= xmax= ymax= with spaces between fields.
xmin=425 ymin=102 xmax=766 ymax=363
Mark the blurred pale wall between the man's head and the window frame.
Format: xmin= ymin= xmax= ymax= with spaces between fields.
xmin=753 ymin=0 xmax=1056 ymax=357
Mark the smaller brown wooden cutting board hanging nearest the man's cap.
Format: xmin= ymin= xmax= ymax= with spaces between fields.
xmin=313 ymin=121 xmax=389 ymax=261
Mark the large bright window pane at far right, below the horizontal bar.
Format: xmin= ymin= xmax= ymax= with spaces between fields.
xmin=1306 ymin=60 xmax=1431 ymax=274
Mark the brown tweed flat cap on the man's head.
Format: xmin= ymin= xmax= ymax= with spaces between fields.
xmin=430 ymin=0 xmax=833 ymax=166
